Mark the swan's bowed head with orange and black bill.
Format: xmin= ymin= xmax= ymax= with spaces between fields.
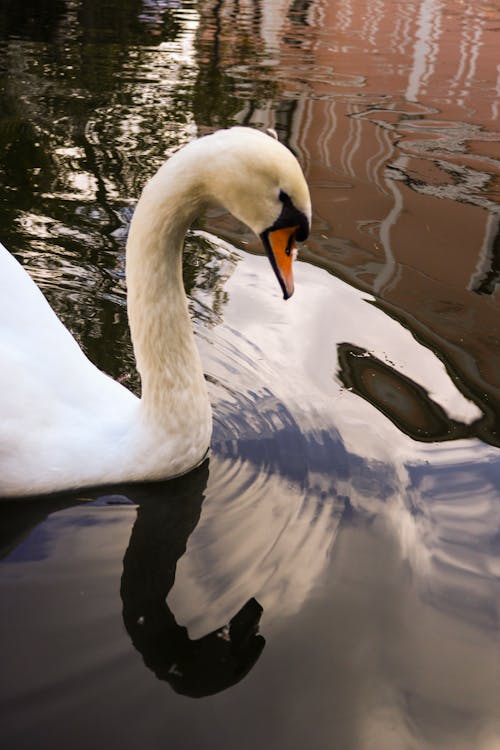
xmin=190 ymin=127 xmax=311 ymax=299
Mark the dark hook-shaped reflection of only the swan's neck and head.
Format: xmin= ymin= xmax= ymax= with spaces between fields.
xmin=120 ymin=460 xmax=265 ymax=698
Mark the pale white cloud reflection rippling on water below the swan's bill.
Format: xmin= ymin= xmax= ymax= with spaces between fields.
xmin=169 ymin=247 xmax=500 ymax=652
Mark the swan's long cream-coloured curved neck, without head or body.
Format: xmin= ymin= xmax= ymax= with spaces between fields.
xmin=126 ymin=157 xmax=209 ymax=431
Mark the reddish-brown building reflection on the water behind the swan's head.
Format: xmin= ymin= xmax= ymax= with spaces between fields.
xmin=195 ymin=0 xmax=500 ymax=440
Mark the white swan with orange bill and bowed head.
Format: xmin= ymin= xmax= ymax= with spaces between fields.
xmin=0 ymin=127 xmax=311 ymax=498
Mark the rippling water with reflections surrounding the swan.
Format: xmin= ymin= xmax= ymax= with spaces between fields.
xmin=0 ymin=0 xmax=500 ymax=750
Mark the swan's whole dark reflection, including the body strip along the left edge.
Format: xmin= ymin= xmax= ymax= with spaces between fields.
xmin=0 ymin=460 xmax=265 ymax=697
